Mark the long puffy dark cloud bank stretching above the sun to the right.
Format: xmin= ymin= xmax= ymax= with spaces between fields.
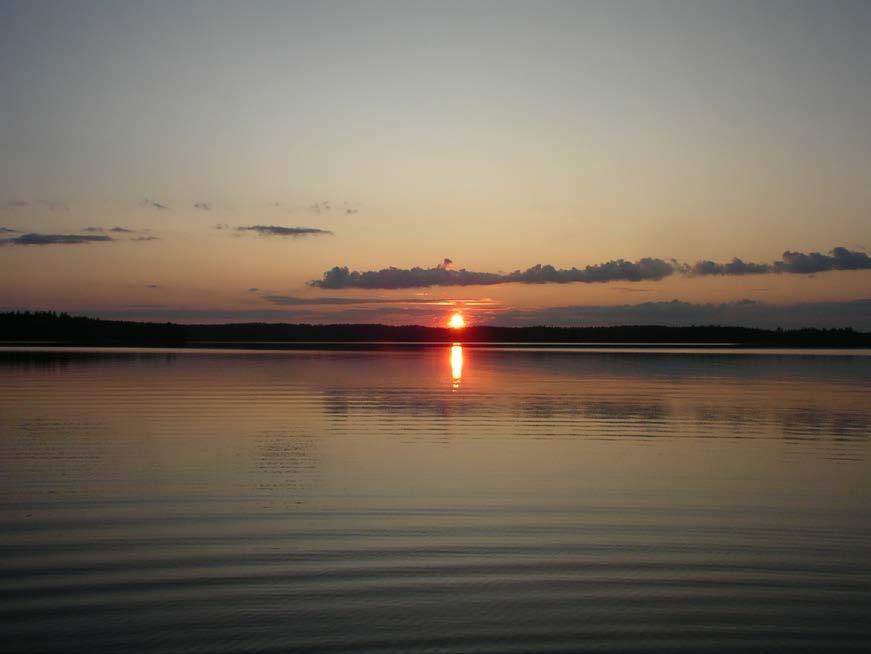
xmin=309 ymin=247 xmax=871 ymax=289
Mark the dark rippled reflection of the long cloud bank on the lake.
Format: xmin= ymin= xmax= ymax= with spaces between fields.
xmin=324 ymin=379 xmax=871 ymax=456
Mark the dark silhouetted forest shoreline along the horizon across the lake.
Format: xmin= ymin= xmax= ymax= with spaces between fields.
xmin=0 ymin=312 xmax=871 ymax=347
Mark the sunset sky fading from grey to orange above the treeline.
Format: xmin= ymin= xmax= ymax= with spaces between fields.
xmin=0 ymin=0 xmax=871 ymax=330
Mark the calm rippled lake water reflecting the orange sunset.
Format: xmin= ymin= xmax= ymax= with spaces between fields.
xmin=0 ymin=346 xmax=871 ymax=652
